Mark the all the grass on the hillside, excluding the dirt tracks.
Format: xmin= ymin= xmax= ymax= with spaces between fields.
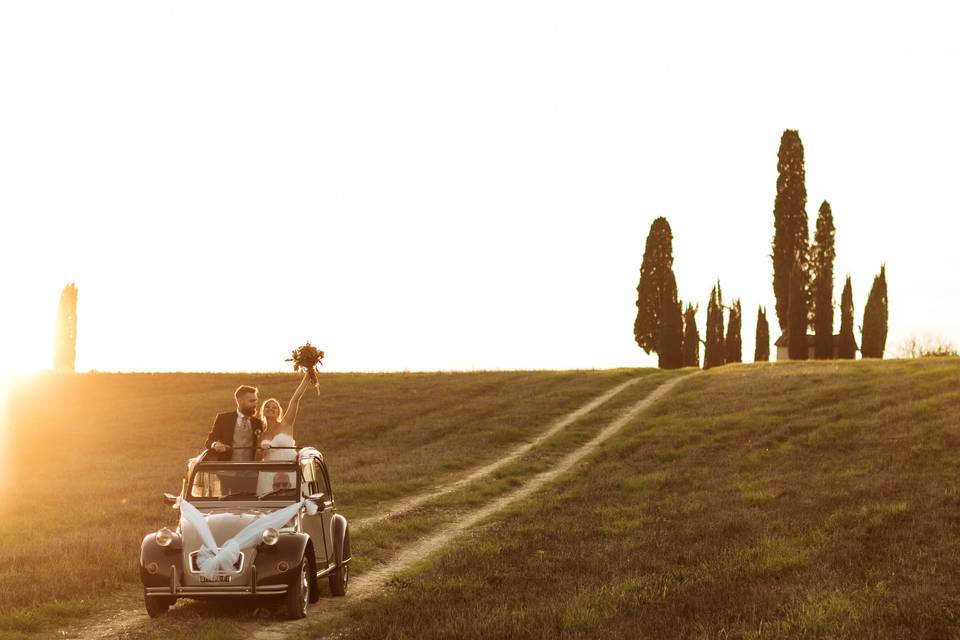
xmin=0 ymin=358 xmax=960 ymax=638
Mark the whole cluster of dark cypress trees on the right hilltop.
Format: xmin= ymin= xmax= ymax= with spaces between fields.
xmin=634 ymin=129 xmax=888 ymax=369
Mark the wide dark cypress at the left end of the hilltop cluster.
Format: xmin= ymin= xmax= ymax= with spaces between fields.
xmin=633 ymin=217 xmax=676 ymax=353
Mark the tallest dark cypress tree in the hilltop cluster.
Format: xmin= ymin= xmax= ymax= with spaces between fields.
xmin=772 ymin=129 xmax=810 ymax=332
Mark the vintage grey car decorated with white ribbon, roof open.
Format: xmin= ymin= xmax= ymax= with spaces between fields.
xmin=140 ymin=447 xmax=350 ymax=618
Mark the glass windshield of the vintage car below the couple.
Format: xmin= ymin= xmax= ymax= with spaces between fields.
xmin=189 ymin=466 xmax=299 ymax=500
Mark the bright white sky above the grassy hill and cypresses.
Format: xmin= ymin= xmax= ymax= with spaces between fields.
xmin=0 ymin=1 xmax=960 ymax=374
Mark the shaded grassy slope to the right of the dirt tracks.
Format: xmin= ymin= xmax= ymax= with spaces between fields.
xmin=313 ymin=359 xmax=960 ymax=639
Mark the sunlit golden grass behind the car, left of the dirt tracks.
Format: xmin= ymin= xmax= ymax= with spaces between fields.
xmin=0 ymin=370 xmax=644 ymax=637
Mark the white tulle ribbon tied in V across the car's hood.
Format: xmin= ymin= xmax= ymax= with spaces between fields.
xmin=177 ymin=498 xmax=317 ymax=579
